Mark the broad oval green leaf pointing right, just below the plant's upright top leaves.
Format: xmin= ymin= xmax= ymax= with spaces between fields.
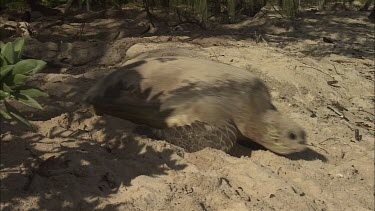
xmin=13 ymin=59 xmax=47 ymax=75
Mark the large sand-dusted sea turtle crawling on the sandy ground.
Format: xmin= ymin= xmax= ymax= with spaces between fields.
xmin=85 ymin=56 xmax=306 ymax=154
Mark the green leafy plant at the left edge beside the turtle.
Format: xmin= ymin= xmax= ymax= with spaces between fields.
xmin=0 ymin=38 xmax=48 ymax=128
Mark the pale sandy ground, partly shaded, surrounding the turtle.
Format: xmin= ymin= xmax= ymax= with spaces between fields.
xmin=0 ymin=6 xmax=375 ymax=211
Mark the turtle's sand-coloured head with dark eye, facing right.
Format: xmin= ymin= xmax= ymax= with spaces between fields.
xmin=254 ymin=110 xmax=306 ymax=155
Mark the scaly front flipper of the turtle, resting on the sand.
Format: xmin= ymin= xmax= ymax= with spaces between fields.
xmin=138 ymin=122 xmax=237 ymax=152
